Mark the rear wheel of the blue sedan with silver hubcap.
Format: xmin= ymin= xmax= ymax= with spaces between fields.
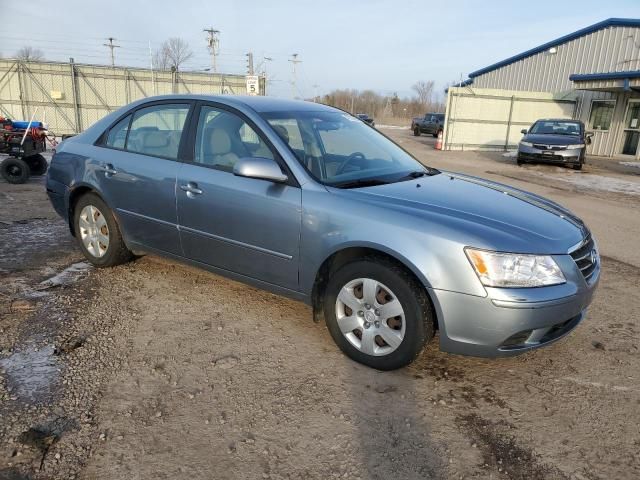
xmin=73 ymin=193 xmax=133 ymax=268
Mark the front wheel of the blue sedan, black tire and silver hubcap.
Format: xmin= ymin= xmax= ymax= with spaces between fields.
xmin=323 ymin=258 xmax=434 ymax=370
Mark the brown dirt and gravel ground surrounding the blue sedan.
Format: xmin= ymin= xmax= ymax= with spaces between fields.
xmin=0 ymin=134 xmax=640 ymax=480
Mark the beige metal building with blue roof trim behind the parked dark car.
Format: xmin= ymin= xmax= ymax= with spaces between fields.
xmin=445 ymin=18 xmax=640 ymax=158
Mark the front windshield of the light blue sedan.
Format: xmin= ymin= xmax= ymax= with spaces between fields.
xmin=262 ymin=111 xmax=437 ymax=188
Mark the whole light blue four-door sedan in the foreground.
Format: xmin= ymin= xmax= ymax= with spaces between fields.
xmin=47 ymin=95 xmax=600 ymax=370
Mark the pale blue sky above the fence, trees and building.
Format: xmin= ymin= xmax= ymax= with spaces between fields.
xmin=0 ymin=0 xmax=640 ymax=98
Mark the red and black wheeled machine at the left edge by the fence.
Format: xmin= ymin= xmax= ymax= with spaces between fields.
xmin=0 ymin=117 xmax=49 ymax=183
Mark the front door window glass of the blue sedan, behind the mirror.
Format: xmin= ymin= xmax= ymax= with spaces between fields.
xmin=194 ymin=106 xmax=274 ymax=172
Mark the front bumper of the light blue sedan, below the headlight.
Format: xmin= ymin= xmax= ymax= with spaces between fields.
xmin=430 ymin=255 xmax=600 ymax=357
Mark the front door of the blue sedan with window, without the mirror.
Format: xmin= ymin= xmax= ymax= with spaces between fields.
xmin=177 ymin=105 xmax=302 ymax=290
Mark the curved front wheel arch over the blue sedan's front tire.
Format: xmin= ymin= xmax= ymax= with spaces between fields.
xmin=310 ymin=244 xmax=438 ymax=329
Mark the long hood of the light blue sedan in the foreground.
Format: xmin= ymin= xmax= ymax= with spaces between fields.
xmin=331 ymin=172 xmax=586 ymax=254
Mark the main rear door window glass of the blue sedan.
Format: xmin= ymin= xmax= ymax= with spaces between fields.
xmin=125 ymin=104 xmax=189 ymax=160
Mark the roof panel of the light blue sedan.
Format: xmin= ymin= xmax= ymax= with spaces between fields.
xmin=131 ymin=94 xmax=336 ymax=112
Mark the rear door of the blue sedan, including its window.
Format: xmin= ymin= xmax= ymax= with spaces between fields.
xmin=92 ymin=102 xmax=192 ymax=255
